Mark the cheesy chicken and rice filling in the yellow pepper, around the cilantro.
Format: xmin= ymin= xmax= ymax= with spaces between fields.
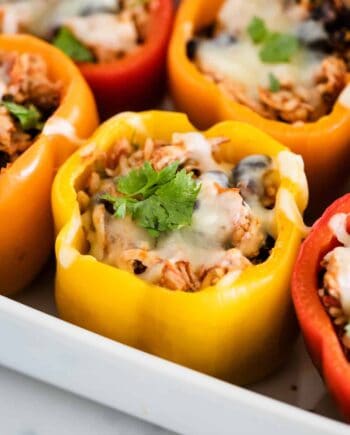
xmin=77 ymin=133 xmax=278 ymax=291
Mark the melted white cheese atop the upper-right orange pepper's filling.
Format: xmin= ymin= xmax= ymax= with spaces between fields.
xmin=197 ymin=0 xmax=325 ymax=98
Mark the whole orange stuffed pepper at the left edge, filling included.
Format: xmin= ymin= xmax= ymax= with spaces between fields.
xmin=0 ymin=35 xmax=98 ymax=294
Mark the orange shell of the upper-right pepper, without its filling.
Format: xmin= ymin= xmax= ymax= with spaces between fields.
xmin=168 ymin=0 xmax=350 ymax=216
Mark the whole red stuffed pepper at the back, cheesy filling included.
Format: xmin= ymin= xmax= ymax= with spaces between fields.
xmin=0 ymin=0 xmax=173 ymax=117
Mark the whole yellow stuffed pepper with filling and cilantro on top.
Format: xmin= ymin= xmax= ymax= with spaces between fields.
xmin=53 ymin=112 xmax=308 ymax=384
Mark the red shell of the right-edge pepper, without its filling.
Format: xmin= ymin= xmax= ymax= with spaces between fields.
xmin=292 ymin=194 xmax=350 ymax=423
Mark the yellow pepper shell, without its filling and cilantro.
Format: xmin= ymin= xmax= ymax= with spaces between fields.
xmin=52 ymin=111 xmax=308 ymax=384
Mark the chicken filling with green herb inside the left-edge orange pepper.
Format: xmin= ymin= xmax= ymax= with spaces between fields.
xmin=0 ymin=52 xmax=61 ymax=169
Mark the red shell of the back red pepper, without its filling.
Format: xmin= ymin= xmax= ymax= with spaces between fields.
xmin=79 ymin=0 xmax=174 ymax=118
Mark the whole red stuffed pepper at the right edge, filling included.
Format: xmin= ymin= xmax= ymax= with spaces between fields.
xmin=292 ymin=194 xmax=350 ymax=422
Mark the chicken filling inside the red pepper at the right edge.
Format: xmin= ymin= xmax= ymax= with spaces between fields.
xmin=319 ymin=213 xmax=350 ymax=358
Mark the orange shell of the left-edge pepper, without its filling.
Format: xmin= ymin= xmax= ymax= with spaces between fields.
xmin=0 ymin=35 xmax=98 ymax=295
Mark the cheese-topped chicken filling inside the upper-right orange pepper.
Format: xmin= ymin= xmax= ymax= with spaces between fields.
xmin=188 ymin=0 xmax=350 ymax=123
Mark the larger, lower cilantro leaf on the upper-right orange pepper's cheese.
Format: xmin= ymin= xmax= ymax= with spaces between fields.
xmin=259 ymin=33 xmax=299 ymax=63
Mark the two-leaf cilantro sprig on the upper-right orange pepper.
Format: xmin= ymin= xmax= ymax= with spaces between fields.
xmin=247 ymin=17 xmax=299 ymax=63
